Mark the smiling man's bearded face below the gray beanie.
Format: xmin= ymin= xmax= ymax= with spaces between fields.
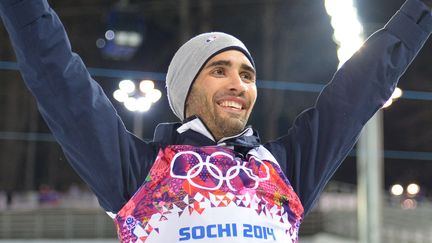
xmin=186 ymin=50 xmax=257 ymax=141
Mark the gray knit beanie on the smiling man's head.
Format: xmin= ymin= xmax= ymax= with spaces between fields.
xmin=166 ymin=32 xmax=255 ymax=121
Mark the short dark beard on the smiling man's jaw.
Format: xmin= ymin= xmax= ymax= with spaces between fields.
xmin=186 ymin=88 xmax=249 ymax=141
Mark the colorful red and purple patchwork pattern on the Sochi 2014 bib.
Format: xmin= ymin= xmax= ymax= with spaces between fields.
xmin=115 ymin=145 xmax=303 ymax=242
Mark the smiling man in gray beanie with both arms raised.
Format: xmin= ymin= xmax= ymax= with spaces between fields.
xmin=0 ymin=0 xmax=432 ymax=243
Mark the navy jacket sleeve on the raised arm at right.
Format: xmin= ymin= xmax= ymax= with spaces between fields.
xmin=266 ymin=0 xmax=432 ymax=213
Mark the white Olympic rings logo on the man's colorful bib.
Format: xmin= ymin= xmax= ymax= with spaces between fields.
xmin=170 ymin=151 xmax=270 ymax=191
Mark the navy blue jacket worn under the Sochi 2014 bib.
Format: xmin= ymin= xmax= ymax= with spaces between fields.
xmin=0 ymin=0 xmax=432 ymax=213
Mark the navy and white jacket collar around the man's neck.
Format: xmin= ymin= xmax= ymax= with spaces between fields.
xmin=153 ymin=116 xmax=260 ymax=148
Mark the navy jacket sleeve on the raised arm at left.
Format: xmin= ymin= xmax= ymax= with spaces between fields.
xmin=0 ymin=0 xmax=156 ymax=212
